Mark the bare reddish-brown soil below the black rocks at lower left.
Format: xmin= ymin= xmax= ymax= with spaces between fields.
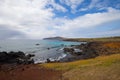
xmin=0 ymin=64 xmax=66 ymax=80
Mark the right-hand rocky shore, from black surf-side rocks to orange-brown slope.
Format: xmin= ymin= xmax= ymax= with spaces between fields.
xmin=63 ymin=41 xmax=120 ymax=61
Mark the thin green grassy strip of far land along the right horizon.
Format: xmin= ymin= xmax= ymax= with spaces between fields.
xmin=65 ymin=37 xmax=120 ymax=42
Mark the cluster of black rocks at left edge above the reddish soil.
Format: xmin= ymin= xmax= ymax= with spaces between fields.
xmin=0 ymin=51 xmax=34 ymax=64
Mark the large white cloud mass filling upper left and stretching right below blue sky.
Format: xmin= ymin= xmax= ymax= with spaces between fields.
xmin=0 ymin=0 xmax=120 ymax=39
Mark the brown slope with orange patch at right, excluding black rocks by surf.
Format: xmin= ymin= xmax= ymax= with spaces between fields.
xmin=76 ymin=42 xmax=120 ymax=56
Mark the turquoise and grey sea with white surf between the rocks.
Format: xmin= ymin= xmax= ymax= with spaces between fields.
xmin=0 ymin=40 xmax=81 ymax=63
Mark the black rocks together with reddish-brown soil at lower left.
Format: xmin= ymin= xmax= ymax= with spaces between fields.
xmin=0 ymin=51 xmax=62 ymax=80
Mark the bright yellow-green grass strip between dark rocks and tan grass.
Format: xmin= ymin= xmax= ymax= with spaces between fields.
xmin=40 ymin=54 xmax=120 ymax=70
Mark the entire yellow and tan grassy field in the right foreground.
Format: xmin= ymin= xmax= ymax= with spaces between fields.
xmin=40 ymin=54 xmax=120 ymax=80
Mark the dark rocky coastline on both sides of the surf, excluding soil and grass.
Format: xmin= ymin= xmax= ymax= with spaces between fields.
xmin=0 ymin=41 xmax=120 ymax=64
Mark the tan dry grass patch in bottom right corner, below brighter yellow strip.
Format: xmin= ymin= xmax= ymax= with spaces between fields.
xmin=63 ymin=63 xmax=120 ymax=80
